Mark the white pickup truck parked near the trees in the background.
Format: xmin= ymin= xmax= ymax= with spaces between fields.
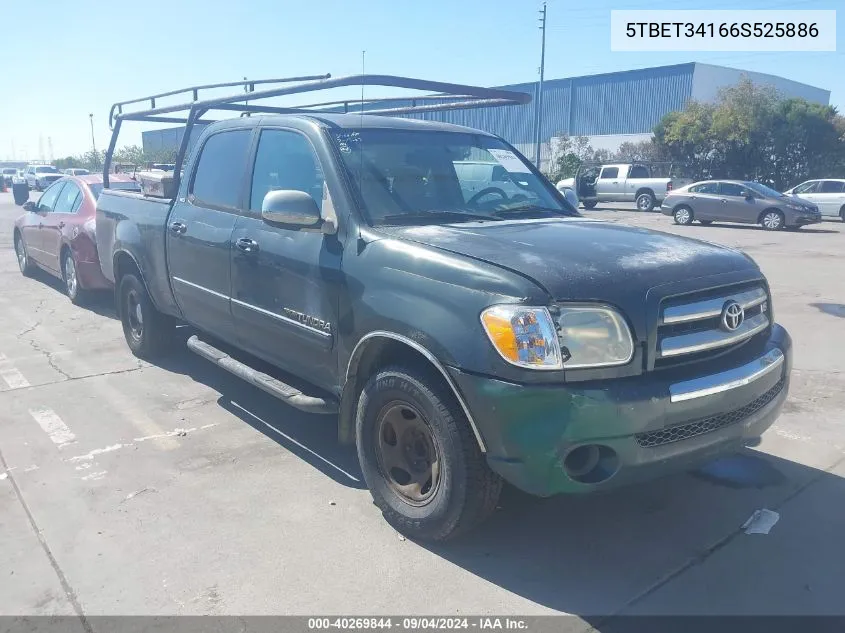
xmin=557 ymin=163 xmax=692 ymax=211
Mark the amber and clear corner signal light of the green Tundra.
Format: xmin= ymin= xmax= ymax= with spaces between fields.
xmin=481 ymin=305 xmax=563 ymax=369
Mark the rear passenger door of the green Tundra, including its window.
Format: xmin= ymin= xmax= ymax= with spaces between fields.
xmin=166 ymin=128 xmax=252 ymax=342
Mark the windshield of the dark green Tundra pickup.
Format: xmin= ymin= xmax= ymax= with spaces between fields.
xmin=332 ymin=129 xmax=576 ymax=225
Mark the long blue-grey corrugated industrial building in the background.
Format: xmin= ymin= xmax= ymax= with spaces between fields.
xmin=143 ymin=62 xmax=830 ymax=170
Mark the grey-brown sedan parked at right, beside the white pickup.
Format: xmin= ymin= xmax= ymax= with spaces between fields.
xmin=660 ymin=180 xmax=822 ymax=231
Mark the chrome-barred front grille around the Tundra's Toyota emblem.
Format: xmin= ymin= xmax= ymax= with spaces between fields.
xmin=655 ymin=286 xmax=769 ymax=367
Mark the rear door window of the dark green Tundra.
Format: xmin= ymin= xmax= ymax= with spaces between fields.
xmin=191 ymin=130 xmax=252 ymax=207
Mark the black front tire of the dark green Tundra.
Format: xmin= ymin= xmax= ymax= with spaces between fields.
xmin=355 ymin=366 xmax=502 ymax=541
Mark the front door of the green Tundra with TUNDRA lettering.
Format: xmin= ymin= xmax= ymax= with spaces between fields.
xmin=232 ymin=128 xmax=342 ymax=389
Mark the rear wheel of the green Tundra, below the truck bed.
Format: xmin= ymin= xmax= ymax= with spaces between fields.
xmin=118 ymin=273 xmax=175 ymax=360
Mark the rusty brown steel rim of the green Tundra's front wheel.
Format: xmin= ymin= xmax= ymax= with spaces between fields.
xmin=376 ymin=402 xmax=441 ymax=506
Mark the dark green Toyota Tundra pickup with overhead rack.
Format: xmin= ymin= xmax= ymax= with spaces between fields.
xmin=97 ymin=77 xmax=791 ymax=540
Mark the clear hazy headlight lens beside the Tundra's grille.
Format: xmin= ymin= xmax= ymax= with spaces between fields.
xmin=558 ymin=305 xmax=634 ymax=369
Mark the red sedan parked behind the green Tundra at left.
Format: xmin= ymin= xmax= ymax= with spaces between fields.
xmin=14 ymin=175 xmax=140 ymax=304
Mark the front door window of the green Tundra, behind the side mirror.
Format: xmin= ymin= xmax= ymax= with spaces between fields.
xmin=249 ymin=130 xmax=325 ymax=211
